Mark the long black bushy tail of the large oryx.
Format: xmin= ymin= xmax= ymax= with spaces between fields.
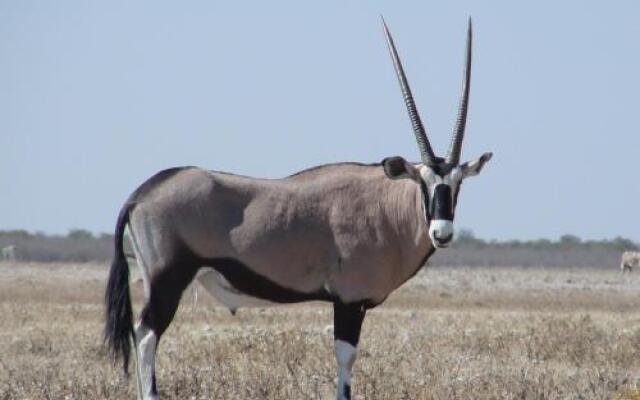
xmin=104 ymin=202 xmax=134 ymax=375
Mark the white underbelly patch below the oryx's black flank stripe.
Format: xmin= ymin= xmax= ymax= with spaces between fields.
xmin=196 ymin=268 xmax=278 ymax=312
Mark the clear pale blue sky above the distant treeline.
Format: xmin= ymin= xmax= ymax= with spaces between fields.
xmin=0 ymin=0 xmax=640 ymax=240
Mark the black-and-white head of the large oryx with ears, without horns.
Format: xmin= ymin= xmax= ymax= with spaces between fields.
xmin=383 ymin=153 xmax=492 ymax=248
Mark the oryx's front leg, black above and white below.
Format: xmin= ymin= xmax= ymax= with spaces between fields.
xmin=333 ymin=302 xmax=366 ymax=400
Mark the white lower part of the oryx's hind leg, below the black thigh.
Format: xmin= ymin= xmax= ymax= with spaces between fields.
xmin=136 ymin=324 xmax=158 ymax=400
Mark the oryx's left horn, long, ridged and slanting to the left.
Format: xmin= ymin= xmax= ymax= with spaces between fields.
xmin=381 ymin=17 xmax=436 ymax=165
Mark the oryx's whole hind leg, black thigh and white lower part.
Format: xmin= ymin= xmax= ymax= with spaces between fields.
xmin=135 ymin=264 xmax=196 ymax=400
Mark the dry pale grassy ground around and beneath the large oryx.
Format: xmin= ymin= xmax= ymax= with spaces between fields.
xmin=0 ymin=263 xmax=640 ymax=399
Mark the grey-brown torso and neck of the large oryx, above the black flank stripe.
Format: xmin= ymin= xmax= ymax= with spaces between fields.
xmin=129 ymin=163 xmax=433 ymax=304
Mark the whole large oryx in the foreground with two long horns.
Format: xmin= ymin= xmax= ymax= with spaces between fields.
xmin=105 ymin=20 xmax=492 ymax=400
